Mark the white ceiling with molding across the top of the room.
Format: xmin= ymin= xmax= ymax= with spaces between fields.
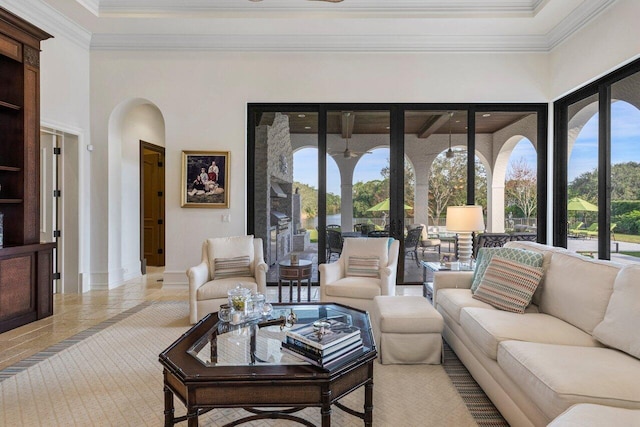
xmin=31 ymin=0 xmax=616 ymax=52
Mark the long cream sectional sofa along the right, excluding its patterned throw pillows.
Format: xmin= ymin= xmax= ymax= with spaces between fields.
xmin=434 ymin=242 xmax=640 ymax=426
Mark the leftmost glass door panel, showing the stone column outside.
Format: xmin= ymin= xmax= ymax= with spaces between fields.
xmin=249 ymin=106 xmax=320 ymax=300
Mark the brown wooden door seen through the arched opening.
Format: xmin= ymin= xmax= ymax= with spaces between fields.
xmin=141 ymin=143 xmax=165 ymax=272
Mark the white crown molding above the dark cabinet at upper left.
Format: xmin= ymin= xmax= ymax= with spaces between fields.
xmin=3 ymin=0 xmax=91 ymax=49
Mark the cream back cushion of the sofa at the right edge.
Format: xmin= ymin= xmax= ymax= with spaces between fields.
xmin=593 ymin=264 xmax=640 ymax=359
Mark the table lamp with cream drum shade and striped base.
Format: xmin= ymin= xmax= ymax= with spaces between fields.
xmin=447 ymin=205 xmax=484 ymax=265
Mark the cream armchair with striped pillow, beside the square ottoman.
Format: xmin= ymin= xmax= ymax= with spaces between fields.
xmin=318 ymin=237 xmax=400 ymax=311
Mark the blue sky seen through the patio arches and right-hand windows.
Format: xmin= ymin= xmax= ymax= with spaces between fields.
xmin=293 ymin=101 xmax=640 ymax=195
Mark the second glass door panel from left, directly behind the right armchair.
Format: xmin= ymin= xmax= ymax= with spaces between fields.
xmin=325 ymin=108 xmax=393 ymax=262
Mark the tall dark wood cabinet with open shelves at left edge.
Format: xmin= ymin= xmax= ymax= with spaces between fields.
xmin=0 ymin=8 xmax=55 ymax=332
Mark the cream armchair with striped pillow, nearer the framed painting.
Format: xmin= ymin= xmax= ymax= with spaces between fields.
xmin=187 ymin=236 xmax=269 ymax=323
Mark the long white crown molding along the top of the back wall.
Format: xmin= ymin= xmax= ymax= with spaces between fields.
xmin=91 ymin=34 xmax=549 ymax=53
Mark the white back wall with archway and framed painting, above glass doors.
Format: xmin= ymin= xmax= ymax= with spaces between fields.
xmin=91 ymin=51 xmax=548 ymax=285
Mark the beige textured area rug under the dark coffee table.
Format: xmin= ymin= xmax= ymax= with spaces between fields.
xmin=0 ymin=302 xmax=476 ymax=427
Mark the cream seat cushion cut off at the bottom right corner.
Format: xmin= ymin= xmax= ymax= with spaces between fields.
xmin=547 ymin=403 xmax=640 ymax=427
